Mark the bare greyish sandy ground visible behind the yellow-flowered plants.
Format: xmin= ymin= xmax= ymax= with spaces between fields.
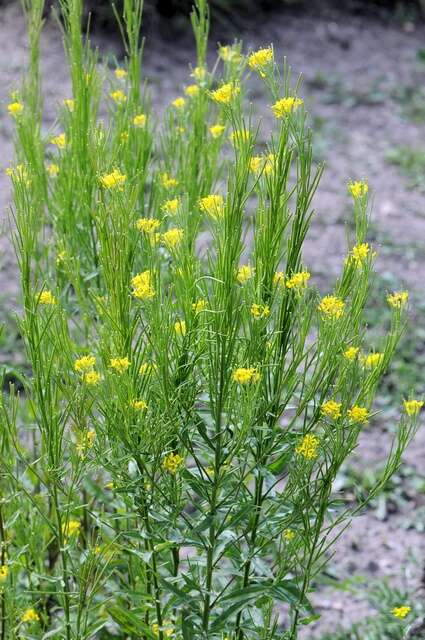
xmin=0 ymin=3 xmax=425 ymax=637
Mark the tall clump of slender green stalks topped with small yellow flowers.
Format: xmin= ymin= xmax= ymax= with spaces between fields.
xmin=0 ymin=0 xmax=422 ymax=640
